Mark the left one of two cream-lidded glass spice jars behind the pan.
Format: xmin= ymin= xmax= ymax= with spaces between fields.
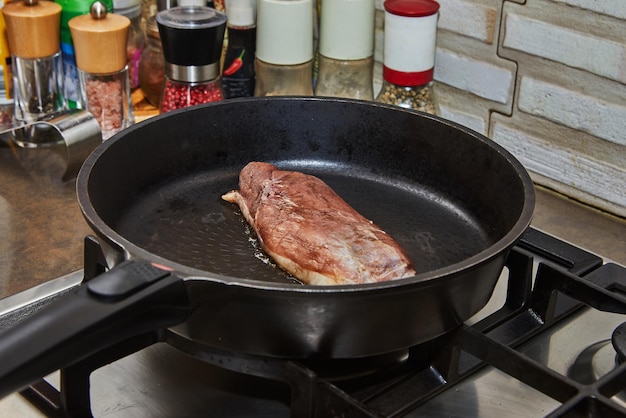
xmin=254 ymin=0 xmax=314 ymax=96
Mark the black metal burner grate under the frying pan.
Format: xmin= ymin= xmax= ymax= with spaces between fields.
xmin=13 ymin=230 xmax=626 ymax=418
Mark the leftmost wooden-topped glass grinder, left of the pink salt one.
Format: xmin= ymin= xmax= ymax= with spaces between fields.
xmin=2 ymin=0 xmax=66 ymax=124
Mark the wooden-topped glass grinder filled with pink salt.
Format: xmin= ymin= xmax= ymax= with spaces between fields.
xmin=68 ymin=1 xmax=134 ymax=139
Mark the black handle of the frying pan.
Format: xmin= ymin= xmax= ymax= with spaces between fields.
xmin=0 ymin=261 xmax=189 ymax=398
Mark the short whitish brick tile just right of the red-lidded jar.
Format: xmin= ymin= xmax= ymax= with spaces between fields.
xmin=435 ymin=48 xmax=514 ymax=104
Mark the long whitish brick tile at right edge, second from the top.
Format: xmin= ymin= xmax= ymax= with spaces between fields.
xmin=503 ymin=12 xmax=626 ymax=82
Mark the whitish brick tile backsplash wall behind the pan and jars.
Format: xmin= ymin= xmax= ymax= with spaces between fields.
xmin=374 ymin=0 xmax=626 ymax=217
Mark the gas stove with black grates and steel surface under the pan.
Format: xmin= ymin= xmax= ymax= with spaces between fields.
xmin=0 ymin=228 xmax=626 ymax=417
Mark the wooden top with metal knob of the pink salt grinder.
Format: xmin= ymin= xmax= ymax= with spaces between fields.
xmin=68 ymin=1 xmax=130 ymax=74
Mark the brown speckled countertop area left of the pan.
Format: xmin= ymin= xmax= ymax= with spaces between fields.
xmin=0 ymin=142 xmax=90 ymax=297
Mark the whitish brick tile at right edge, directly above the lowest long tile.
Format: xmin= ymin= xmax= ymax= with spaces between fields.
xmin=518 ymin=77 xmax=626 ymax=145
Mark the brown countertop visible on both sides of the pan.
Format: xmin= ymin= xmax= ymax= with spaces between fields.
xmin=0 ymin=131 xmax=626 ymax=298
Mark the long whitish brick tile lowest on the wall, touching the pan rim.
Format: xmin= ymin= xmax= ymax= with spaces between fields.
xmin=492 ymin=122 xmax=626 ymax=210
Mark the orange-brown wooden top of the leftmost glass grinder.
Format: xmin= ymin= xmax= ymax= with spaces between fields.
xmin=2 ymin=0 xmax=61 ymax=59
